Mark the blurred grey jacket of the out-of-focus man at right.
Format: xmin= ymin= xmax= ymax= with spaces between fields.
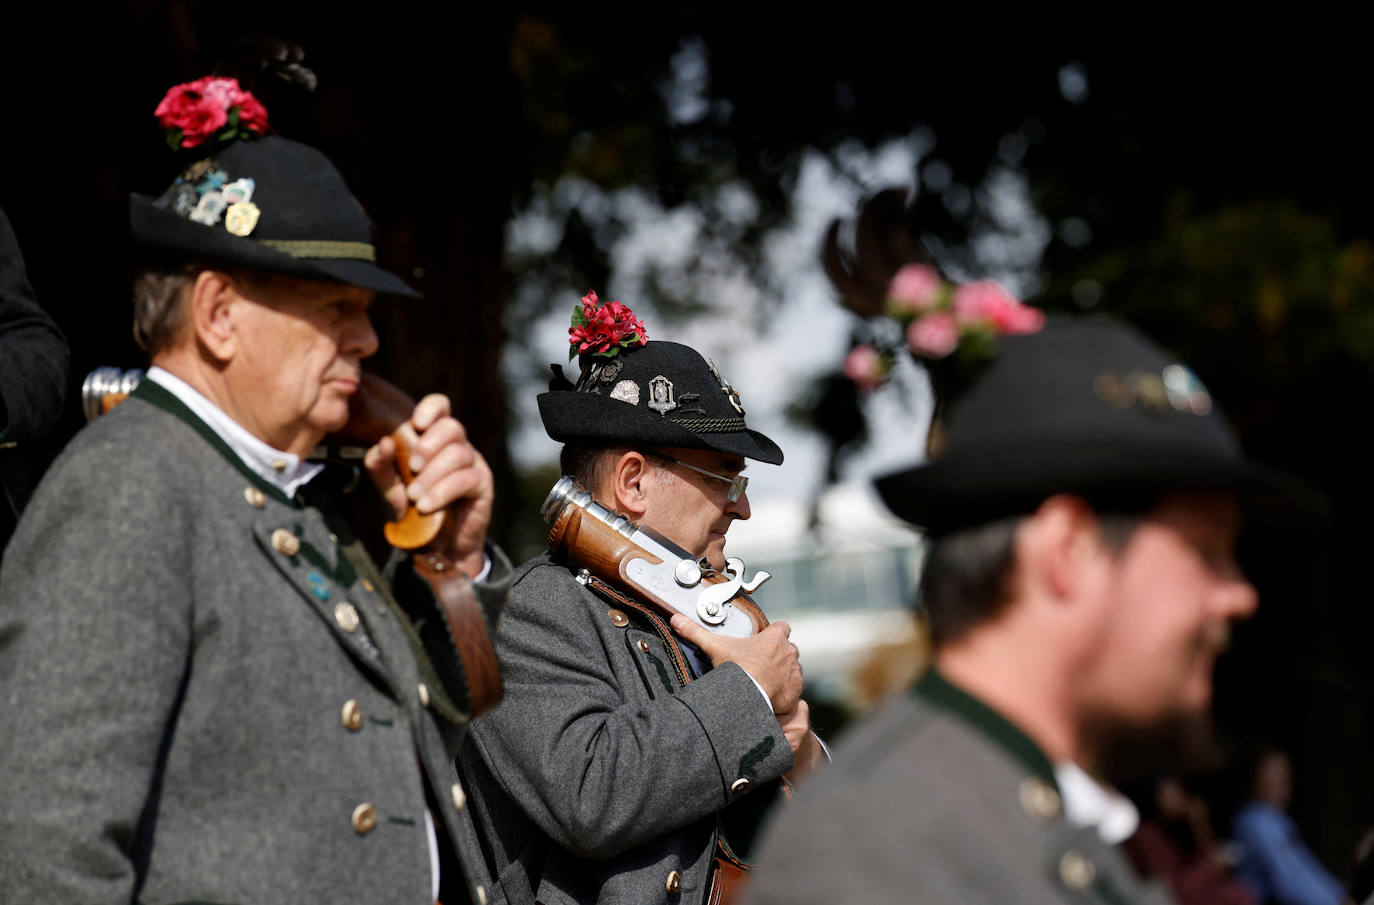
xmin=745 ymin=670 xmax=1173 ymax=905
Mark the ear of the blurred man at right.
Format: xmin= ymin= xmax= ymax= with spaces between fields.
xmin=1017 ymin=494 xmax=1107 ymax=602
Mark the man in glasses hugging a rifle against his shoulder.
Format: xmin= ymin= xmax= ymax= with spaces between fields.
xmin=460 ymin=329 xmax=826 ymax=905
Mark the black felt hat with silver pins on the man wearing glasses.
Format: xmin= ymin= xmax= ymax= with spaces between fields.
xmin=539 ymin=341 xmax=782 ymax=466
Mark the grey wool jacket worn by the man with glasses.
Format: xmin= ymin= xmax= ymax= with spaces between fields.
xmin=462 ymin=555 xmax=793 ymax=905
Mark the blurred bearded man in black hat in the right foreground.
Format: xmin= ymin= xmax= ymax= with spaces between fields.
xmin=750 ymin=323 xmax=1319 ymax=905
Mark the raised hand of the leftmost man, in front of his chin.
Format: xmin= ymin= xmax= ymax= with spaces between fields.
xmin=363 ymin=393 xmax=495 ymax=575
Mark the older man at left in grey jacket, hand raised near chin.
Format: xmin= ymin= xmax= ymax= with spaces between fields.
xmin=0 ymin=77 xmax=510 ymax=905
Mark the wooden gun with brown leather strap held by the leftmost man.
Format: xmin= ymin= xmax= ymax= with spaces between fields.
xmin=81 ymin=368 xmax=502 ymax=717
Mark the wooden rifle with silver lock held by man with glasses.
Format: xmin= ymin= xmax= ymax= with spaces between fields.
xmin=541 ymin=475 xmax=772 ymax=637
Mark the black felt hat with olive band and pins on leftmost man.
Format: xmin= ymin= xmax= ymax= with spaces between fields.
xmin=129 ymin=135 xmax=418 ymax=297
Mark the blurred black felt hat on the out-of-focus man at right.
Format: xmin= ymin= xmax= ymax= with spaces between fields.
xmin=875 ymin=320 xmax=1322 ymax=531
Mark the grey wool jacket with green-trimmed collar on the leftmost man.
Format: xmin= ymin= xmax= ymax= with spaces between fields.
xmin=0 ymin=380 xmax=510 ymax=905
